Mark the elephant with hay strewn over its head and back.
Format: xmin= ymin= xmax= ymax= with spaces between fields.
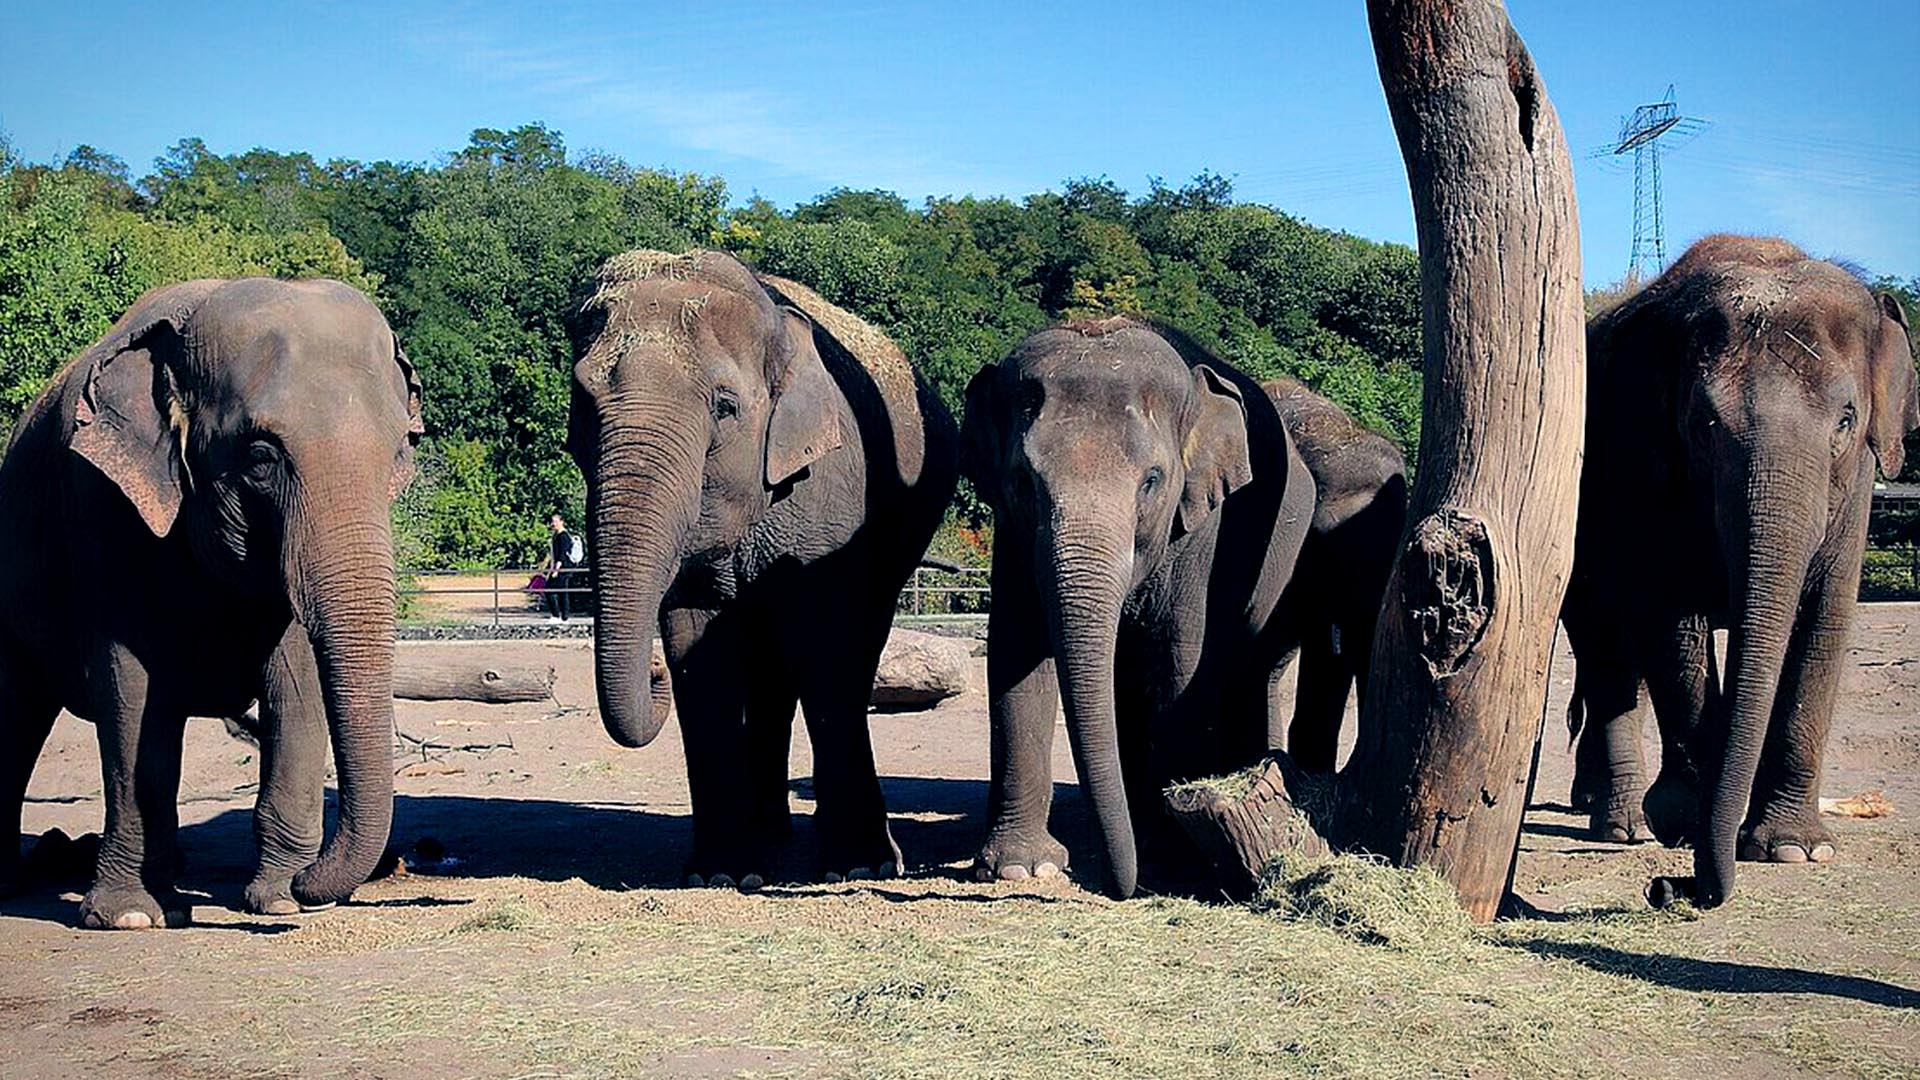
xmin=568 ymin=250 xmax=958 ymax=888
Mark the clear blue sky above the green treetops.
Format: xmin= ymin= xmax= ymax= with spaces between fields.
xmin=0 ymin=0 xmax=1920 ymax=282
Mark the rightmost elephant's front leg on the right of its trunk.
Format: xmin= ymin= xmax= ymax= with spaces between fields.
xmin=1738 ymin=557 xmax=1859 ymax=863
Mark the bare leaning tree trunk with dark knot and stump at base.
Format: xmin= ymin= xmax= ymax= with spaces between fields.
xmin=1169 ymin=0 xmax=1586 ymax=920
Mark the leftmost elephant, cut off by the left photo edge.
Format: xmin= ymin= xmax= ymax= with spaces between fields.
xmin=0 ymin=279 xmax=420 ymax=928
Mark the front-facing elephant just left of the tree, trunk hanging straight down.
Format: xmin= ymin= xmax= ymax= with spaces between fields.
xmin=962 ymin=315 xmax=1313 ymax=897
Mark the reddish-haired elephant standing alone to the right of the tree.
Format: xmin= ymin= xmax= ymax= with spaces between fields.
xmin=1563 ymin=234 xmax=1920 ymax=907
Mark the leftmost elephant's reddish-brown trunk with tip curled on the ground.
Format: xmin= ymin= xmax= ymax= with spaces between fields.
xmin=292 ymin=503 xmax=394 ymax=907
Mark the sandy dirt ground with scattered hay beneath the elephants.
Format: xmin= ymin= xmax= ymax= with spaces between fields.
xmin=0 ymin=605 xmax=1920 ymax=1080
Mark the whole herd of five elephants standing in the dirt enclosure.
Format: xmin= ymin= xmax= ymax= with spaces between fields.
xmin=0 ymin=236 xmax=1920 ymax=928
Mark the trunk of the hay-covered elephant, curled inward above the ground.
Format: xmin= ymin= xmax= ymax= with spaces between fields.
xmin=588 ymin=417 xmax=701 ymax=748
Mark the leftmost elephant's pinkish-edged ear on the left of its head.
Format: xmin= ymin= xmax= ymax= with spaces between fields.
xmin=67 ymin=290 xmax=219 ymax=536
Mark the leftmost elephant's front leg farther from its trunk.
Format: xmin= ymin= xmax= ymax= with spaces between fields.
xmin=81 ymin=653 xmax=188 ymax=930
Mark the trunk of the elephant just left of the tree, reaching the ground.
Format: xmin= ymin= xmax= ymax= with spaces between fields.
xmin=1035 ymin=500 xmax=1139 ymax=899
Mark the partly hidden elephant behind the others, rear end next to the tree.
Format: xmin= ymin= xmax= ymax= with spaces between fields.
xmin=1263 ymin=377 xmax=1407 ymax=773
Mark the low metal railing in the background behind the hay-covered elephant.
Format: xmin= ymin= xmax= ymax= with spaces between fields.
xmin=399 ymin=563 xmax=991 ymax=626
